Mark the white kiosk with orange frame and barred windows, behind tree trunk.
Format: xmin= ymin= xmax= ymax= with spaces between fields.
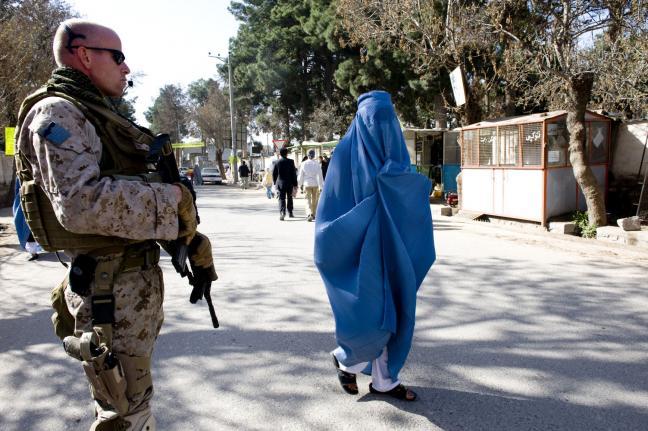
xmin=460 ymin=111 xmax=611 ymax=226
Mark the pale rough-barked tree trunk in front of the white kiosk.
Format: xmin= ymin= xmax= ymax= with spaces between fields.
xmin=567 ymin=73 xmax=607 ymax=226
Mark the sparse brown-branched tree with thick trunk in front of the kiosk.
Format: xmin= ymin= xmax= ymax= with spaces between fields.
xmin=483 ymin=0 xmax=648 ymax=226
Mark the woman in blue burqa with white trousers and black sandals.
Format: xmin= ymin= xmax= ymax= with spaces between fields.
xmin=315 ymin=91 xmax=435 ymax=401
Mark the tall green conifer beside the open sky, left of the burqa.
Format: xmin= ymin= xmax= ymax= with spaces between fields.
xmin=230 ymin=0 xmax=321 ymax=139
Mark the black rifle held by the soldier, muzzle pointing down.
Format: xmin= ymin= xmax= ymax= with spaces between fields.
xmin=147 ymin=133 xmax=220 ymax=328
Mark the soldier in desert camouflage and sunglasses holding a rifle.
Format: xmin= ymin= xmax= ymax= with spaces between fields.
xmin=16 ymin=19 xmax=216 ymax=431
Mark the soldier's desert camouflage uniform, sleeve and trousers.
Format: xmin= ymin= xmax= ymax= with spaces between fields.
xmin=17 ymin=97 xmax=178 ymax=420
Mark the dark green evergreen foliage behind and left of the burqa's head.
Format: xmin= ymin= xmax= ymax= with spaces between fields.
xmin=228 ymin=0 xmax=446 ymax=140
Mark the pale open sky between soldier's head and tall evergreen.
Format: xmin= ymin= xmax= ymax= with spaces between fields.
xmin=65 ymin=0 xmax=238 ymax=126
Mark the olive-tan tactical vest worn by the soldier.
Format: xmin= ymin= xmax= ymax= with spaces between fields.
xmin=15 ymin=86 xmax=160 ymax=252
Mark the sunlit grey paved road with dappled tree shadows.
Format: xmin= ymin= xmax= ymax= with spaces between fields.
xmin=0 ymin=186 xmax=648 ymax=431
